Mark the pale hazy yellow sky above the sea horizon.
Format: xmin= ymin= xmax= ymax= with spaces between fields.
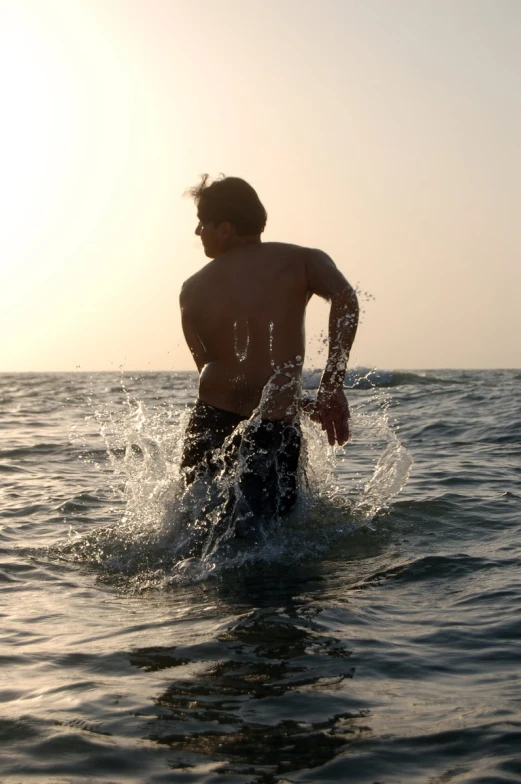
xmin=0 ymin=0 xmax=521 ymax=372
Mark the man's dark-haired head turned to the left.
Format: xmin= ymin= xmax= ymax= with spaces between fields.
xmin=188 ymin=174 xmax=268 ymax=259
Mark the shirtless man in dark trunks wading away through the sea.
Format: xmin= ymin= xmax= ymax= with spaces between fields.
xmin=180 ymin=175 xmax=358 ymax=535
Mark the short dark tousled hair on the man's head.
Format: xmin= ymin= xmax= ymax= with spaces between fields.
xmin=187 ymin=174 xmax=268 ymax=237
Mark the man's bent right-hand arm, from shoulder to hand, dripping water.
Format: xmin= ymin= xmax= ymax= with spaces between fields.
xmin=306 ymin=250 xmax=359 ymax=446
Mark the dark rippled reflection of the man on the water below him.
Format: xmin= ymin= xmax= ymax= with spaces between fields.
xmin=130 ymin=567 xmax=371 ymax=782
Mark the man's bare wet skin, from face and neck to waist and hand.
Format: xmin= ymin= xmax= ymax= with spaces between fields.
xmin=180 ymin=222 xmax=358 ymax=443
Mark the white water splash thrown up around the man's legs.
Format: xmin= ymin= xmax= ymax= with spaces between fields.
xmin=54 ymin=374 xmax=411 ymax=591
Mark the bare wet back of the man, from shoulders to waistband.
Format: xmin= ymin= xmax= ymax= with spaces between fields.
xmin=182 ymin=242 xmax=315 ymax=419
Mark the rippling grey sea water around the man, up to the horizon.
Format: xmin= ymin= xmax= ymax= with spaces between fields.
xmin=0 ymin=370 xmax=521 ymax=784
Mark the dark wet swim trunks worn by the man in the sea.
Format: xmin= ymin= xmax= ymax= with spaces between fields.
xmin=181 ymin=400 xmax=301 ymax=520
